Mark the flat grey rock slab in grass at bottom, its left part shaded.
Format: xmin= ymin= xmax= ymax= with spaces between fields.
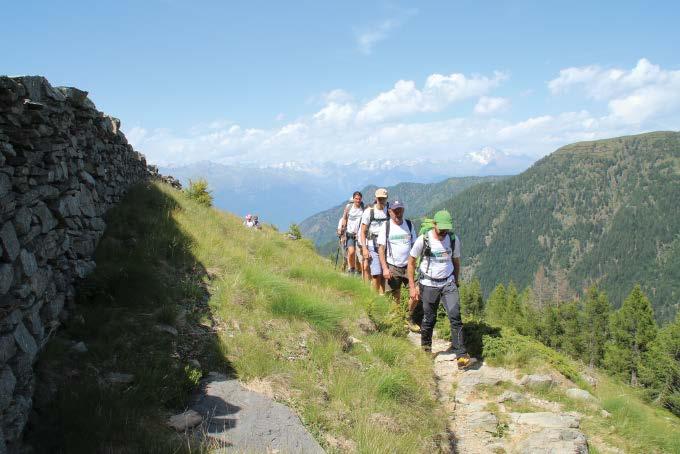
xmin=191 ymin=373 xmax=324 ymax=454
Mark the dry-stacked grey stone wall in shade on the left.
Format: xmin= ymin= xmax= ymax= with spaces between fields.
xmin=0 ymin=77 xmax=148 ymax=453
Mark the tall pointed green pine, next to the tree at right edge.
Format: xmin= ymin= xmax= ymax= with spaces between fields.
xmin=604 ymin=284 xmax=657 ymax=386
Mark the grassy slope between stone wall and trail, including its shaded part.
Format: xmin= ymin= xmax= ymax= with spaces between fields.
xmin=28 ymin=185 xmax=445 ymax=452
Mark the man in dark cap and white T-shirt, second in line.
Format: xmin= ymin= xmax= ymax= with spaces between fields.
xmin=377 ymin=200 xmax=416 ymax=303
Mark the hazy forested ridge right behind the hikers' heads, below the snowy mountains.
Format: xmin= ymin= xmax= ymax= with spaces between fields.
xmin=300 ymin=176 xmax=507 ymax=254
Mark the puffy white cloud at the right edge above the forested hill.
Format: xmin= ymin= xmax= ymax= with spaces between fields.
xmin=548 ymin=58 xmax=680 ymax=124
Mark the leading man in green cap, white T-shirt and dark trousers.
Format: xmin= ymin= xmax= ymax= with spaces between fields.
xmin=408 ymin=210 xmax=470 ymax=367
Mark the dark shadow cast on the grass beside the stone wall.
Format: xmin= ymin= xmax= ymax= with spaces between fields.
xmin=25 ymin=184 xmax=234 ymax=453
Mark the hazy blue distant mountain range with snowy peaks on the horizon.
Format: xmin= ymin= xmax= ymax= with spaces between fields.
xmin=160 ymin=147 xmax=533 ymax=229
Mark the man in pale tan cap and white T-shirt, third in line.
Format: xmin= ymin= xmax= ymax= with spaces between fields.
xmin=359 ymin=188 xmax=388 ymax=295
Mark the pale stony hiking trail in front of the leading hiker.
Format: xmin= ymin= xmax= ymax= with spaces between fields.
xmin=409 ymin=333 xmax=588 ymax=454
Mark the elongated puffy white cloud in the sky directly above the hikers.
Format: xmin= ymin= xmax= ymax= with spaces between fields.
xmin=357 ymin=71 xmax=507 ymax=122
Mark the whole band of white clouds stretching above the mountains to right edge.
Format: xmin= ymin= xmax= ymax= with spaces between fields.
xmin=123 ymin=59 xmax=680 ymax=171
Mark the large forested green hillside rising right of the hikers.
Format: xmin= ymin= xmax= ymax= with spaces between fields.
xmin=438 ymin=132 xmax=680 ymax=321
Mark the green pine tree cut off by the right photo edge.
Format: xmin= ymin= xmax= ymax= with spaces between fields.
xmin=640 ymin=314 xmax=680 ymax=416
